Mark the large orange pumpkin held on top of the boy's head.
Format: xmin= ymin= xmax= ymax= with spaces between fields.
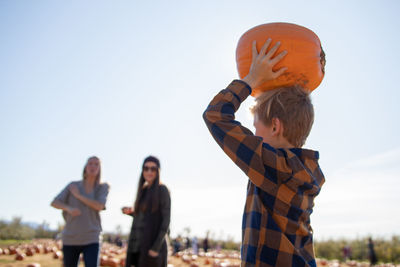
xmin=236 ymin=22 xmax=325 ymax=96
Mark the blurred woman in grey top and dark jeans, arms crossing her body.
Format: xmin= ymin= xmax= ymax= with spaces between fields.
xmin=51 ymin=157 xmax=109 ymax=267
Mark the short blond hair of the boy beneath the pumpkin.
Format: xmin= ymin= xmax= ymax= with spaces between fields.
xmin=251 ymin=86 xmax=314 ymax=147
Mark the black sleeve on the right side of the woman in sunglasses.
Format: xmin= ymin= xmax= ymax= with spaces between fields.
xmin=151 ymin=186 xmax=171 ymax=252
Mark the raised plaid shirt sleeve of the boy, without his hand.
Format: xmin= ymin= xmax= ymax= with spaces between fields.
xmin=203 ymin=80 xmax=292 ymax=190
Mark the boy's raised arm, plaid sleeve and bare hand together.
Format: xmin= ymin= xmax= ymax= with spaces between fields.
xmin=203 ymin=40 xmax=290 ymax=189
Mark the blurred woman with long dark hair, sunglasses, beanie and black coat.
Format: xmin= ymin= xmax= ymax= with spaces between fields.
xmin=122 ymin=156 xmax=171 ymax=267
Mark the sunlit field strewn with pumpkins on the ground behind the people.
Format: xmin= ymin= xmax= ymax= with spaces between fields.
xmin=0 ymin=239 xmax=400 ymax=267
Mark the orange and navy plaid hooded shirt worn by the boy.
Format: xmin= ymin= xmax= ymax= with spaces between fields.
xmin=203 ymin=80 xmax=325 ymax=267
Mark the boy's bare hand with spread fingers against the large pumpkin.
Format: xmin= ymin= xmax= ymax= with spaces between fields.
xmin=243 ymin=38 xmax=287 ymax=89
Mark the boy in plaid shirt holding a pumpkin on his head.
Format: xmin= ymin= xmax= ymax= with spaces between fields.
xmin=203 ymin=39 xmax=325 ymax=267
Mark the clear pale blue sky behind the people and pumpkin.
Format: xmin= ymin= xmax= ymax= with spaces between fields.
xmin=0 ymin=0 xmax=400 ymax=243
